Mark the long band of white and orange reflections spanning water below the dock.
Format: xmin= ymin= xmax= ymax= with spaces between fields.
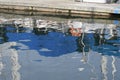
xmin=1 ymin=18 xmax=116 ymax=39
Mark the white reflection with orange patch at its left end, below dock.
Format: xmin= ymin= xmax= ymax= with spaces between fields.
xmin=68 ymin=21 xmax=116 ymax=39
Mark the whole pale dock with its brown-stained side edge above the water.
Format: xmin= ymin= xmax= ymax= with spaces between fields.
xmin=0 ymin=0 xmax=120 ymax=16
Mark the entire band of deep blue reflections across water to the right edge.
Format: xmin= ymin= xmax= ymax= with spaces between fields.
xmin=7 ymin=28 xmax=120 ymax=57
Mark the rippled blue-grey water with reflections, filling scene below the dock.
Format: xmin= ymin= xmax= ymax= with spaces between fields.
xmin=0 ymin=14 xmax=120 ymax=80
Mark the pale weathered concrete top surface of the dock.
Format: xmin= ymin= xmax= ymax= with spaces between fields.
xmin=0 ymin=0 xmax=120 ymax=14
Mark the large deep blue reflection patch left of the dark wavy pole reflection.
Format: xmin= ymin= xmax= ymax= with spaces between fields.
xmin=7 ymin=28 xmax=77 ymax=57
